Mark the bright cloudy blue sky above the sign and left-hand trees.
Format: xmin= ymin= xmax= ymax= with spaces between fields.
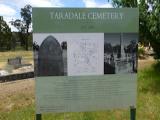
xmin=0 ymin=0 xmax=112 ymax=31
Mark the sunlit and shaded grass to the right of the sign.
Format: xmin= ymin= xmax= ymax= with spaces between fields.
xmin=137 ymin=63 xmax=160 ymax=120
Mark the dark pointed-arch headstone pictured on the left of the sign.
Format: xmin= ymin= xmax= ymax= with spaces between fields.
xmin=37 ymin=36 xmax=64 ymax=76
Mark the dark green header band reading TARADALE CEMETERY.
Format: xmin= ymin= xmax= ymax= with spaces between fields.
xmin=33 ymin=8 xmax=139 ymax=33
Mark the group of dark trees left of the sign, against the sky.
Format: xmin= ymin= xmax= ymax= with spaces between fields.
xmin=0 ymin=5 xmax=32 ymax=51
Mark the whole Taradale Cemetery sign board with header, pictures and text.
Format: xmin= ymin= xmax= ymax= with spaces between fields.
xmin=33 ymin=8 xmax=139 ymax=113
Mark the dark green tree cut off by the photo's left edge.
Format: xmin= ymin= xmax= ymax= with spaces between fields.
xmin=0 ymin=16 xmax=12 ymax=51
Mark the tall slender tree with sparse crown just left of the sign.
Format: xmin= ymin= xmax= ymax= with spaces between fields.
xmin=21 ymin=5 xmax=32 ymax=50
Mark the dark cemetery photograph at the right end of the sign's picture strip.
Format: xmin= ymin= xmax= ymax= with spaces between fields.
xmin=104 ymin=33 xmax=138 ymax=74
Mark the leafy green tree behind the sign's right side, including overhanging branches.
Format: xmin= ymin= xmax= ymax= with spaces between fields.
xmin=113 ymin=0 xmax=160 ymax=59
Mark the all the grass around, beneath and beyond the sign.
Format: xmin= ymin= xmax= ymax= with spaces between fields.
xmin=0 ymin=51 xmax=160 ymax=120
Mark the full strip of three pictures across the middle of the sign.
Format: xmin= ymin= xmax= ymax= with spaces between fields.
xmin=33 ymin=33 xmax=138 ymax=76
